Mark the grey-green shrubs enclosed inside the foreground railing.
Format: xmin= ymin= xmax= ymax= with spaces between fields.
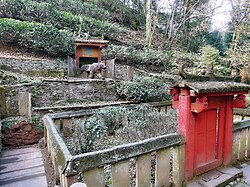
xmin=73 ymin=104 xmax=176 ymax=154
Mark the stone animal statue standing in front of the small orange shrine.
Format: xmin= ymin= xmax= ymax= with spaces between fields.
xmin=80 ymin=62 xmax=107 ymax=79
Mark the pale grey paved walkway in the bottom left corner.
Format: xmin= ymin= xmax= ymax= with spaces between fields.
xmin=0 ymin=147 xmax=47 ymax=187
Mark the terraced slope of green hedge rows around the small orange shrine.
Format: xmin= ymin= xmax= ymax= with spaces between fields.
xmin=0 ymin=0 xmax=198 ymax=74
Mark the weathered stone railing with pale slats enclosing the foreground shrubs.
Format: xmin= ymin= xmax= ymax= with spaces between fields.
xmin=43 ymin=105 xmax=185 ymax=187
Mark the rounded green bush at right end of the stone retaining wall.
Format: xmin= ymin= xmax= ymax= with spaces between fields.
xmin=116 ymin=77 xmax=170 ymax=102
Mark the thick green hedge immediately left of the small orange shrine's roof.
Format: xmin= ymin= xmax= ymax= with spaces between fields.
xmin=0 ymin=18 xmax=74 ymax=56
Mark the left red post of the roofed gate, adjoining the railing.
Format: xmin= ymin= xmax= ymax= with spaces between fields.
xmin=178 ymin=88 xmax=194 ymax=180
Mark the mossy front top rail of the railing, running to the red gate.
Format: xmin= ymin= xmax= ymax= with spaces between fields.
xmin=72 ymin=134 xmax=184 ymax=171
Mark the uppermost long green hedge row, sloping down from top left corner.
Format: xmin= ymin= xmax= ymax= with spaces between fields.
xmin=1 ymin=0 xmax=120 ymax=35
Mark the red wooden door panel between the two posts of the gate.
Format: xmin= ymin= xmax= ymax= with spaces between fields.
xmin=194 ymin=98 xmax=225 ymax=175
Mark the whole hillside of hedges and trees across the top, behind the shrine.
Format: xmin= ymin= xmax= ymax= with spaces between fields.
xmin=0 ymin=0 xmax=249 ymax=75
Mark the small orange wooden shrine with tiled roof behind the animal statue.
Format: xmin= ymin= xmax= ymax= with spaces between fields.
xmin=75 ymin=38 xmax=109 ymax=68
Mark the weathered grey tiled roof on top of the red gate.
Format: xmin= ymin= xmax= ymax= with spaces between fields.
xmin=173 ymin=81 xmax=250 ymax=94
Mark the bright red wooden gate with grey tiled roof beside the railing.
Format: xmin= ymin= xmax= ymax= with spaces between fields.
xmin=170 ymin=81 xmax=250 ymax=180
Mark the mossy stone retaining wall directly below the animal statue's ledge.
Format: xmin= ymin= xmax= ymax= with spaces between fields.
xmin=4 ymin=79 xmax=118 ymax=116
